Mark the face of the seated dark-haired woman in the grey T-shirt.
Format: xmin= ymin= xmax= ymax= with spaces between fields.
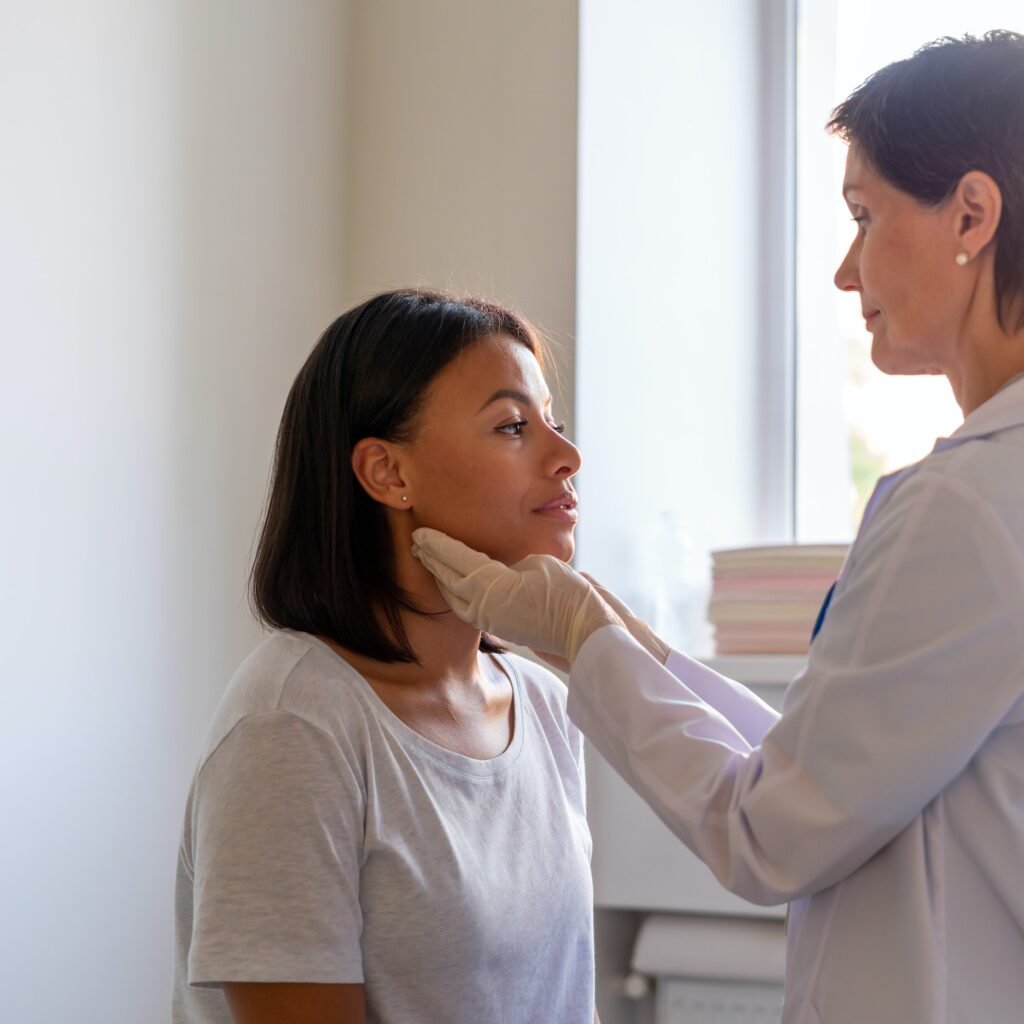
xmin=402 ymin=335 xmax=580 ymax=564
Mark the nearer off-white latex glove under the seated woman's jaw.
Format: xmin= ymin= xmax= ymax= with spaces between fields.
xmin=413 ymin=528 xmax=623 ymax=663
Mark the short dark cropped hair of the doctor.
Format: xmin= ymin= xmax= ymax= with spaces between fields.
xmin=827 ymin=31 xmax=1024 ymax=330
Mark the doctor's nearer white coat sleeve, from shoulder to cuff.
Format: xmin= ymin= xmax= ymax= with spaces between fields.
xmin=568 ymin=470 xmax=1024 ymax=904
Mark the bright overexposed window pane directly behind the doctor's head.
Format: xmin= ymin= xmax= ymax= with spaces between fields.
xmin=795 ymin=0 xmax=1024 ymax=542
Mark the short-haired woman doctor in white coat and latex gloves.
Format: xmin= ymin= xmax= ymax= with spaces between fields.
xmin=414 ymin=33 xmax=1024 ymax=1024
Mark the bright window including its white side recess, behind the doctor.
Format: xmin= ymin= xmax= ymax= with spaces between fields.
xmin=575 ymin=0 xmax=1024 ymax=650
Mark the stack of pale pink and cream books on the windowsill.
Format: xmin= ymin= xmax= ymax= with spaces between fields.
xmin=708 ymin=544 xmax=849 ymax=654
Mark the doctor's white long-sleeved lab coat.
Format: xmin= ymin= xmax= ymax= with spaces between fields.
xmin=569 ymin=381 xmax=1024 ymax=1024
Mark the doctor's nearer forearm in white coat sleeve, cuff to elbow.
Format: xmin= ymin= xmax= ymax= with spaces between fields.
xmin=568 ymin=630 xmax=885 ymax=905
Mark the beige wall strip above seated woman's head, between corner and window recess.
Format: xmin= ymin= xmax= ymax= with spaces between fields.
xmin=345 ymin=0 xmax=578 ymax=424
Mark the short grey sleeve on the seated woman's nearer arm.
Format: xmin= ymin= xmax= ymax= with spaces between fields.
xmin=188 ymin=712 xmax=365 ymax=985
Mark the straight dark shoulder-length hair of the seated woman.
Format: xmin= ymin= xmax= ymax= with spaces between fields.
xmin=250 ymin=289 xmax=544 ymax=662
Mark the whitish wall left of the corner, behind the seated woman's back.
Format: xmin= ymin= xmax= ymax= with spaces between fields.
xmin=0 ymin=0 xmax=348 ymax=1024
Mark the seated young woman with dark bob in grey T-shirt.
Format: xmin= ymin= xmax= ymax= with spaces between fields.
xmin=174 ymin=291 xmax=595 ymax=1024
